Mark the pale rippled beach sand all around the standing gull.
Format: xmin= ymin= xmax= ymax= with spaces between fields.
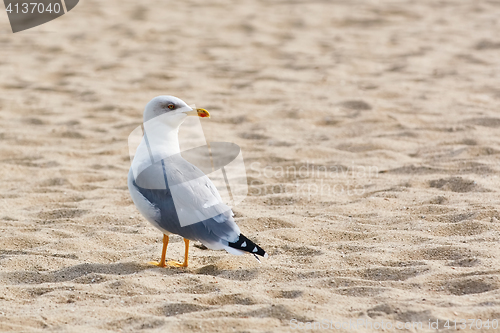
xmin=0 ymin=0 xmax=500 ymax=333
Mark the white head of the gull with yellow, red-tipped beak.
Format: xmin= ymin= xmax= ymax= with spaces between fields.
xmin=144 ymin=95 xmax=210 ymax=128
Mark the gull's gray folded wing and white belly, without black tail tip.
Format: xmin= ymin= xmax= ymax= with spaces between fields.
xmin=129 ymin=154 xmax=240 ymax=249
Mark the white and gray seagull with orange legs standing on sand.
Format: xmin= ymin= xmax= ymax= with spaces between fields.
xmin=128 ymin=95 xmax=268 ymax=267
